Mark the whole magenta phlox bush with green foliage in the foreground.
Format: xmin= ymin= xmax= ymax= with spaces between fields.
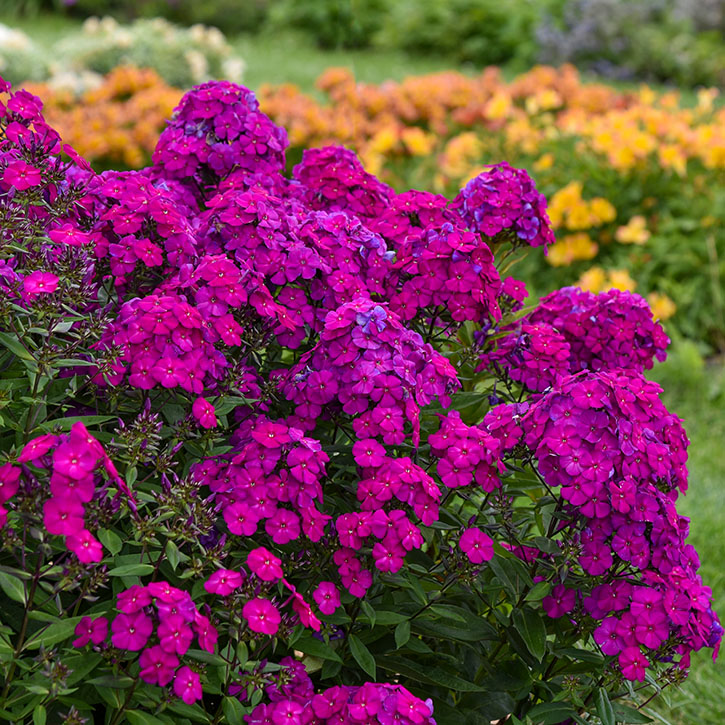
xmin=0 ymin=73 xmax=723 ymax=725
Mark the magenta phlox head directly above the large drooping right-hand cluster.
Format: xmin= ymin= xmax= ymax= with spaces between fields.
xmin=526 ymin=287 xmax=670 ymax=374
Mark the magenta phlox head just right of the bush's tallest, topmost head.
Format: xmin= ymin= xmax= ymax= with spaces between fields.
xmin=292 ymin=146 xmax=394 ymax=218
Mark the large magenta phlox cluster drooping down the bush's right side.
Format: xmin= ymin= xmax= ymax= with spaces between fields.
xmin=484 ymin=370 xmax=722 ymax=680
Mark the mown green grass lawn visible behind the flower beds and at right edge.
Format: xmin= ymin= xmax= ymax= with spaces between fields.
xmin=0 ymin=9 xmax=725 ymax=725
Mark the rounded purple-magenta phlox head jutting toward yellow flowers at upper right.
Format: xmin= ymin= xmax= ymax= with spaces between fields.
xmin=451 ymin=161 xmax=554 ymax=247
